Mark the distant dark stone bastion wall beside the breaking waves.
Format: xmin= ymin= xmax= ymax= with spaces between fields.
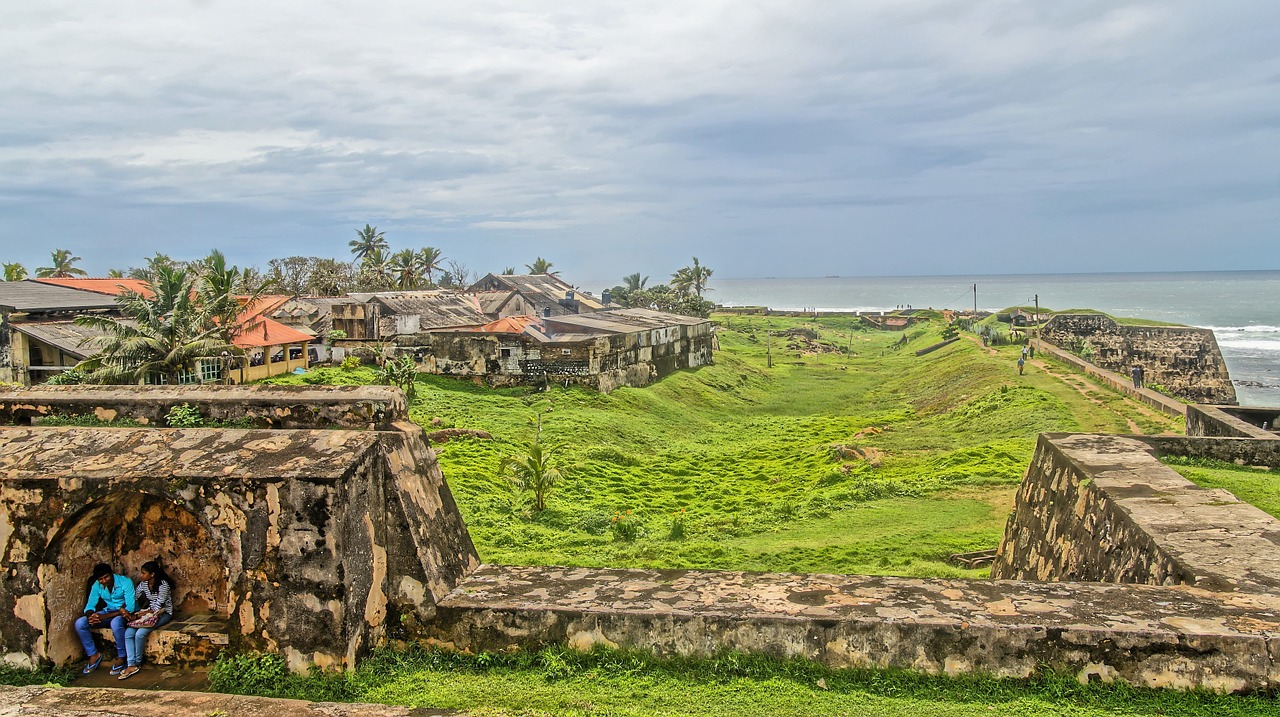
xmin=1042 ymin=314 xmax=1236 ymax=405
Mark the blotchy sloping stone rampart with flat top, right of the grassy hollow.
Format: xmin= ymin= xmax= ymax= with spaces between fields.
xmin=991 ymin=434 xmax=1280 ymax=594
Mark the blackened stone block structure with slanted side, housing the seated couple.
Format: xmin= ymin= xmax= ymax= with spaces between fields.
xmin=0 ymin=389 xmax=479 ymax=670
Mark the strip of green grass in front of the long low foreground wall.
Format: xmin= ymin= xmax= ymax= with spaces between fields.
xmin=194 ymin=648 xmax=1277 ymax=717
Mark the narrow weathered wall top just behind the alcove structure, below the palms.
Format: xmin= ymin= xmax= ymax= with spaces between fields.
xmin=0 ymin=385 xmax=408 ymax=429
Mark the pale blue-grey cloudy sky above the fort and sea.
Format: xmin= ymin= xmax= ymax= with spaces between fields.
xmin=0 ymin=0 xmax=1280 ymax=279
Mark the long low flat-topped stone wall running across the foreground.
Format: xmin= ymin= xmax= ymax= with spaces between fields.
xmin=436 ymin=566 xmax=1280 ymax=691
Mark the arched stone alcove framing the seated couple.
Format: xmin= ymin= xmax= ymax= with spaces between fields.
xmin=40 ymin=490 xmax=230 ymax=663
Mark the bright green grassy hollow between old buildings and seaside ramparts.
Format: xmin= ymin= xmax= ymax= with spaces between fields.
xmin=264 ymin=318 xmax=1167 ymax=576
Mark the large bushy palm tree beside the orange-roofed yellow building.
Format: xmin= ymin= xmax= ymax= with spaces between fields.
xmin=76 ymin=266 xmax=239 ymax=384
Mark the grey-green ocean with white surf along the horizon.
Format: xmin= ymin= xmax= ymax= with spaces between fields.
xmin=707 ymin=271 xmax=1280 ymax=406
